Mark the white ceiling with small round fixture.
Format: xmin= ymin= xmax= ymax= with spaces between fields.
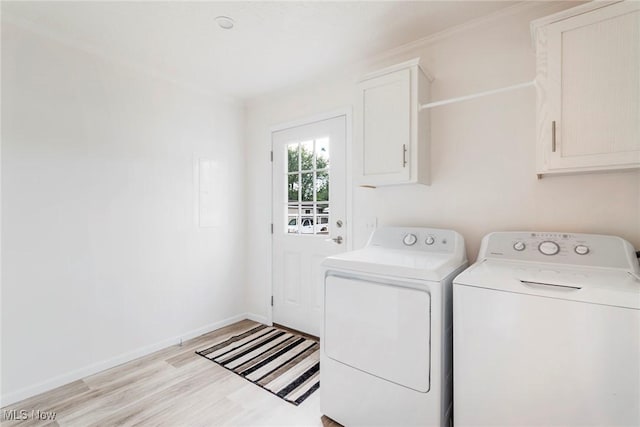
xmin=2 ymin=1 xmax=516 ymax=99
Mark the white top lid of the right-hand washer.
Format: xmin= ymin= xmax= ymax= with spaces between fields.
xmin=454 ymin=260 xmax=640 ymax=310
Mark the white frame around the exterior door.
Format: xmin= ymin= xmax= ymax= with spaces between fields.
xmin=265 ymin=106 xmax=353 ymax=325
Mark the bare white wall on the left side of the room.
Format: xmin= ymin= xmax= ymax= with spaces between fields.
xmin=2 ymin=22 xmax=245 ymax=405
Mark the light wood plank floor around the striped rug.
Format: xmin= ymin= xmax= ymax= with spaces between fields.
xmin=0 ymin=320 xmax=335 ymax=427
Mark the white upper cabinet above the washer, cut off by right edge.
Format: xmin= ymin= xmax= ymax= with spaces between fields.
xmin=531 ymin=1 xmax=640 ymax=175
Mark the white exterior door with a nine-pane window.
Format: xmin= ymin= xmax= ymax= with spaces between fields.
xmin=272 ymin=116 xmax=347 ymax=336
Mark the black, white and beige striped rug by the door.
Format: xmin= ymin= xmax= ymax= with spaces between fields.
xmin=196 ymin=325 xmax=320 ymax=405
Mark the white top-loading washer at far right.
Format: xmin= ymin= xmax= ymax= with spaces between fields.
xmin=453 ymin=232 xmax=640 ymax=427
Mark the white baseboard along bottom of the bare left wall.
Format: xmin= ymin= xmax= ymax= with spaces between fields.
xmin=0 ymin=313 xmax=248 ymax=408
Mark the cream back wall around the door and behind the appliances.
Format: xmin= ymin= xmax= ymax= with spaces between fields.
xmin=247 ymin=4 xmax=640 ymax=315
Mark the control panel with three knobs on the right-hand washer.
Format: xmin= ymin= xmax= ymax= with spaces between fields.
xmin=478 ymin=231 xmax=639 ymax=271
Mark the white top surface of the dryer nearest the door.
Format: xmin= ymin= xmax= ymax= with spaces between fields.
xmin=322 ymin=246 xmax=466 ymax=282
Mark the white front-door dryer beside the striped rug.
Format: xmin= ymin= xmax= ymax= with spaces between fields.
xmin=320 ymin=227 xmax=467 ymax=426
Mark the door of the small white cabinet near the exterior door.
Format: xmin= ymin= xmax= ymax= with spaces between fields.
xmin=360 ymin=69 xmax=411 ymax=185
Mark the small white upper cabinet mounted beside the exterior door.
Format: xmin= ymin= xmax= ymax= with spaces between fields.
xmin=354 ymin=58 xmax=430 ymax=187
